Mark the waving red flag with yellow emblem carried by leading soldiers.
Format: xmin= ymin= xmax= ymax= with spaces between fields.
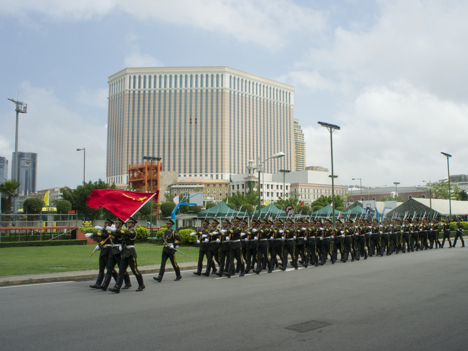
xmin=86 ymin=189 xmax=159 ymax=222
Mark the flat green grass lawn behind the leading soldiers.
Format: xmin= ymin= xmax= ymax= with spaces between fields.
xmin=0 ymin=243 xmax=199 ymax=276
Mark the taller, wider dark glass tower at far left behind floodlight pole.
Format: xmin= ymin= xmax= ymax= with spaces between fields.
xmin=11 ymin=152 xmax=37 ymax=195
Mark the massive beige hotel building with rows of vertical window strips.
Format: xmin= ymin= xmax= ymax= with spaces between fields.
xmin=106 ymin=66 xmax=305 ymax=183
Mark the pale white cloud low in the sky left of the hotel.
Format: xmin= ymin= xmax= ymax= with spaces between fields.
xmin=0 ymin=81 xmax=107 ymax=190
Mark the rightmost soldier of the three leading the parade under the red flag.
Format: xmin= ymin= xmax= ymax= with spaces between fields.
xmin=109 ymin=217 xmax=145 ymax=294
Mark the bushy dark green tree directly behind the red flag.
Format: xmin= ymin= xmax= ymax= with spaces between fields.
xmin=61 ymin=179 xmax=116 ymax=218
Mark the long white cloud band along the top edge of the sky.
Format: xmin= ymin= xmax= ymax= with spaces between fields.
xmin=0 ymin=0 xmax=327 ymax=50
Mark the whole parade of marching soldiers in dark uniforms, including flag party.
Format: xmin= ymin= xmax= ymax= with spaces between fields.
xmin=86 ymin=215 xmax=465 ymax=293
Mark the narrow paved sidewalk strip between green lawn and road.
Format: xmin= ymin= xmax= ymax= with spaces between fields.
xmin=0 ymin=262 xmax=199 ymax=286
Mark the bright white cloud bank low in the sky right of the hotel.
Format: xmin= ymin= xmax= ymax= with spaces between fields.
xmin=304 ymin=81 xmax=468 ymax=185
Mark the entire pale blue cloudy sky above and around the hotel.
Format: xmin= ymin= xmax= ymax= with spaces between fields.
xmin=0 ymin=0 xmax=468 ymax=189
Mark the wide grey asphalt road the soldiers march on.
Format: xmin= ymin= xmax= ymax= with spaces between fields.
xmin=0 ymin=248 xmax=468 ymax=351
